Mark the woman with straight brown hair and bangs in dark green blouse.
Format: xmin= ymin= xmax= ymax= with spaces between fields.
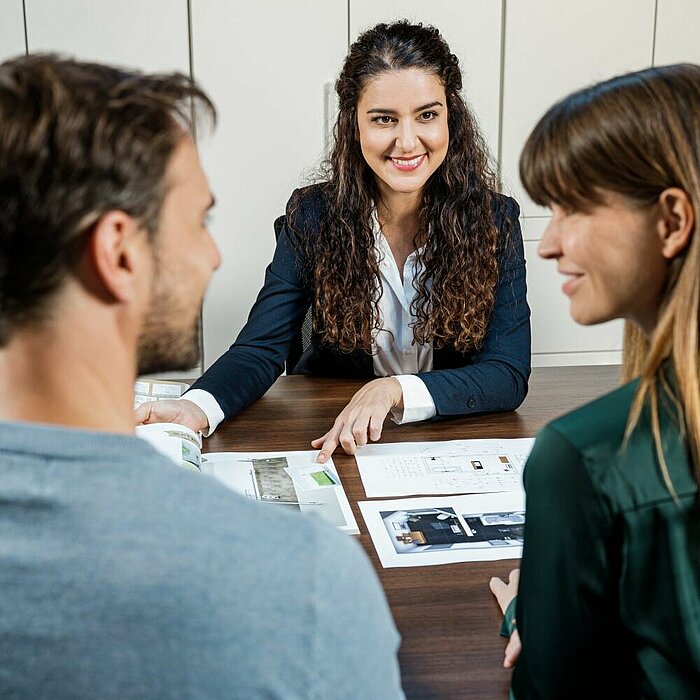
xmin=491 ymin=65 xmax=700 ymax=700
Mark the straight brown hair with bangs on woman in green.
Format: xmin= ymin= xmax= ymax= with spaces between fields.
xmin=520 ymin=64 xmax=700 ymax=495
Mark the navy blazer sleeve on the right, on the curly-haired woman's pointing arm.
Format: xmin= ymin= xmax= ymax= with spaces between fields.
xmin=418 ymin=196 xmax=530 ymax=416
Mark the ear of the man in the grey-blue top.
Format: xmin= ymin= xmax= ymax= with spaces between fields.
xmin=88 ymin=210 xmax=152 ymax=302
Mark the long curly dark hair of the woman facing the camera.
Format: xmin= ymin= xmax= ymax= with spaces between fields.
xmin=290 ymin=20 xmax=498 ymax=352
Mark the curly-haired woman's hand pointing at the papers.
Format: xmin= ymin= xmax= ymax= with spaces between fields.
xmin=311 ymin=377 xmax=403 ymax=462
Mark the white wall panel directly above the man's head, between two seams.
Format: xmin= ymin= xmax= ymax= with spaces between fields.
xmin=25 ymin=0 xmax=189 ymax=73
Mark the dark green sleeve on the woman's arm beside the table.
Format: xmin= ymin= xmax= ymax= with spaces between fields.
xmin=513 ymin=426 xmax=618 ymax=700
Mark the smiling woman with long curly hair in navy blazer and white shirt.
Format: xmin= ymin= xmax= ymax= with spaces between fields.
xmin=138 ymin=21 xmax=530 ymax=461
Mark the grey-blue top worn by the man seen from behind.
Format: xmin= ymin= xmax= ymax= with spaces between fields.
xmin=0 ymin=423 xmax=403 ymax=700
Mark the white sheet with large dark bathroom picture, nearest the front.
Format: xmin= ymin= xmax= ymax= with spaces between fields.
xmin=358 ymin=490 xmax=525 ymax=569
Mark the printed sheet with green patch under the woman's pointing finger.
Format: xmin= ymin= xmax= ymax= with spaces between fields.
xmin=201 ymin=450 xmax=360 ymax=535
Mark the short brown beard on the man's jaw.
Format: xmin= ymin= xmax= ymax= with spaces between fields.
xmin=138 ymin=304 xmax=201 ymax=375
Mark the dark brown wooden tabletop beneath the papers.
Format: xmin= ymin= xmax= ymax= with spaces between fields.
xmin=204 ymin=366 xmax=620 ymax=700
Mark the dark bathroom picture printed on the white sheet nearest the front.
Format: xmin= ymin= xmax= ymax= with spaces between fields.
xmin=380 ymin=507 xmax=525 ymax=554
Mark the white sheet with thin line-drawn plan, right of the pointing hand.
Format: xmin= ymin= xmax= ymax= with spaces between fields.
xmin=355 ymin=438 xmax=535 ymax=498
